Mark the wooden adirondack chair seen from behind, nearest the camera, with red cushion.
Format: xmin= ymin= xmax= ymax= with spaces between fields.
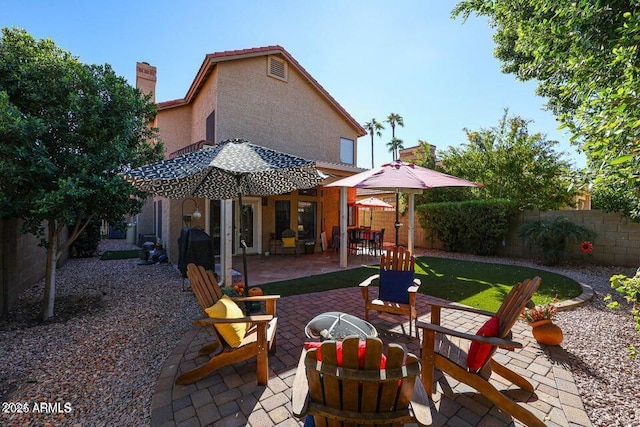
xmin=291 ymin=336 xmax=431 ymax=426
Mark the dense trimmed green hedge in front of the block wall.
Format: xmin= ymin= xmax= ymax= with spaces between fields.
xmin=417 ymin=199 xmax=518 ymax=255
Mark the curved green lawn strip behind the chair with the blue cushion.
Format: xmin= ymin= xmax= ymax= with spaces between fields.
xmin=260 ymin=257 xmax=582 ymax=312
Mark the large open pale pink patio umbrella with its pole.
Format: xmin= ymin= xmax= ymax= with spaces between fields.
xmin=327 ymin=160 xmax=482 ymax=250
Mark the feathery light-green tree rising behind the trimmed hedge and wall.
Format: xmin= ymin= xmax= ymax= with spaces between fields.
xmin=441 ymin=110 xmax=577 ymax=209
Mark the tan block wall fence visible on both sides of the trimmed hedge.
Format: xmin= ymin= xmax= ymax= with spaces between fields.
xmin=358 ymin=209 xmax=640 ymax=267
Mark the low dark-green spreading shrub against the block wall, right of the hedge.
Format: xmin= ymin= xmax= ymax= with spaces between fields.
xmin=518 ymin=216 xmax=596 ymax=265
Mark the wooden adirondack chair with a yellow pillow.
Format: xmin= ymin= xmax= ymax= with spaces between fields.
xmin=176 ymin=263 xmax=280 ymax=385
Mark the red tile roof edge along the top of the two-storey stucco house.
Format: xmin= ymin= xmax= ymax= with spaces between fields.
xmin=157 ymin=45 xmax=367 ymax=136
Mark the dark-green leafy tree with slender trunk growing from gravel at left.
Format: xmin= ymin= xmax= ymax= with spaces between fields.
xmin=0 ymin=28 xmax=164 ymax=320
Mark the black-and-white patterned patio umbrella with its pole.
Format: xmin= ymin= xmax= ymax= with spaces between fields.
xmin=122 ymin=139 xmax=323 ymax=289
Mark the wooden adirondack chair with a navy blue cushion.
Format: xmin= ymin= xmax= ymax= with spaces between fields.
xmin=359 ymin=246 xmax=420 ymax=336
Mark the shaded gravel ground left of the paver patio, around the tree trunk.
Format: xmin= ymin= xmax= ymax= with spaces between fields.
xmin=0 ymin=240 xmax=199 ymax=427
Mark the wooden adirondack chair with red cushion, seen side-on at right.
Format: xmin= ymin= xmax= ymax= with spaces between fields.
xmin=416 ymin=277 xmax=545 ymax=427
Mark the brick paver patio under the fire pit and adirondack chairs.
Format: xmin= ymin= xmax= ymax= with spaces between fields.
xmin=151 ymin=280 xmax=592 ymax=427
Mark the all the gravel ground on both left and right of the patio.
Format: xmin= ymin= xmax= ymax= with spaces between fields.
xmin=0 ymin=240 xmax=640 ymax=426
